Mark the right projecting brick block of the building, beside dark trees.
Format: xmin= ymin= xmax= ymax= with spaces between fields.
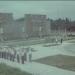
xmin=25 ymin=14 xmax=50 ymax=37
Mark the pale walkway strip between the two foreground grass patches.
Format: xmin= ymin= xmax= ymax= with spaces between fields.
xmin=0 ymin=59 xmax=75 ymax=75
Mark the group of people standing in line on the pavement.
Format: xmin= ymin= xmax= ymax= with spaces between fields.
xmin=0 ymin=47 xmax=32 ymax=64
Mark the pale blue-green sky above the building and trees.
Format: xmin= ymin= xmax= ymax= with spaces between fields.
xmin=0 ymin=1 xmax=75 ymax=20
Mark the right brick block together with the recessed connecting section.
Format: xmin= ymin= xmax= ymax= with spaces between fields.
xmin=15 ymin=14 xmax=50 ymax=38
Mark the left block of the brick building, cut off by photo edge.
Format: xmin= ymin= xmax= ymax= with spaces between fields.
xmin=0 ymin=13 xmax=14 ymax=40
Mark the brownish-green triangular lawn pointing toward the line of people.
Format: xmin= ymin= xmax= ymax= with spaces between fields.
xmin=34 ymin=55 xmax=75 ymax=71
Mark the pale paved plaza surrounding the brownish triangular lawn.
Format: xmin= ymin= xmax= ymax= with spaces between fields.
xmin=0 ymin=39 xmax=75 ymax=75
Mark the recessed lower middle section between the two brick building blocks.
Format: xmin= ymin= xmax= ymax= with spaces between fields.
xmin=15 ymin=18 xmax=25 ymax=39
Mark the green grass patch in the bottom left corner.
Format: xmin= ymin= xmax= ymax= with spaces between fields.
xmin=0 ymin=64 xmax=31 ymax=75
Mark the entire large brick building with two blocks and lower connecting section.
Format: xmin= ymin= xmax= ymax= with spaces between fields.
xmin=0 ymin=13 xmax=50 ymax=40
